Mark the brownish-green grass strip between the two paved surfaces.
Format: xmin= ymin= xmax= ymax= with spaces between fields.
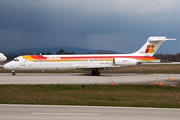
xmin=0 ymin=85 xmax=180 ymax=108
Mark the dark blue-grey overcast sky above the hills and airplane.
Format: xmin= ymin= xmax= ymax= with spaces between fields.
xmin=0 ymin=0 xmax=180 ymax=54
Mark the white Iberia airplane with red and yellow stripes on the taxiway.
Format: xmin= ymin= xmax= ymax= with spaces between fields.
xmin=3 ymin=36 xmax=176 ymax=75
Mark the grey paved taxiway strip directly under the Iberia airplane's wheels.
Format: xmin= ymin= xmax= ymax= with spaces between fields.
xmin=0 ymin=73 xmax=180 ymax=85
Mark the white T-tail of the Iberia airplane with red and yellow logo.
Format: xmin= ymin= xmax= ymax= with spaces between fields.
xmin=133 ymin=36 xmax=176 ymax=57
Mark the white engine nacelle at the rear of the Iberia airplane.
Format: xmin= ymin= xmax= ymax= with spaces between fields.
xmin=114 ymin=58 xmax=138 ymax=67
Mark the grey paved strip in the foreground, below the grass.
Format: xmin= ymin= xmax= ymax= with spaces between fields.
xmin=0 ymin=104 xmax=180 ymax=120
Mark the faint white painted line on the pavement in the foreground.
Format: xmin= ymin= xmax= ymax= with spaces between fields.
xmin=32 ymin=113 xmax=100 ymax=116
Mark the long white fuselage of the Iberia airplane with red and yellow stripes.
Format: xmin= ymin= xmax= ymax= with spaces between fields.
xmin=4 ymin=54 xmax=156 ymax=70
